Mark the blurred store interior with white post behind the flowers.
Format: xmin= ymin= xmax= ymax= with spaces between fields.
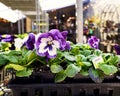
xmin=0 ymin=0 xmax=120 ymax=52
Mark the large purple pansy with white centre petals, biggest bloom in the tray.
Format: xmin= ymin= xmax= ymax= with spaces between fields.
xmin=36 ymin=29 xmax=70 ymax=58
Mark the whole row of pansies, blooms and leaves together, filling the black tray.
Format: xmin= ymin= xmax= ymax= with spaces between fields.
xmin=0 ymin=29 xmax=120 ymax=83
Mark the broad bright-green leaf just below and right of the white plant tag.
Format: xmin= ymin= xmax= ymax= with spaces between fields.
xmin=99 ymin=64 xmax=118 ymax=75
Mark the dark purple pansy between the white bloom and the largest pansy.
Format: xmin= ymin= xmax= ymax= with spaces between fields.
xmin=24 ymin=33 xmax=35 ymax=50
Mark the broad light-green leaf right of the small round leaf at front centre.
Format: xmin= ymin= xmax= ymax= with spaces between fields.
xmin=65 ymin=64 xmax=81 ymax=77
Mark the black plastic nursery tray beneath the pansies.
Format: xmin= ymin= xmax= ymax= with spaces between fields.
xmin=7 ymin=74 xmax=120 ymax=96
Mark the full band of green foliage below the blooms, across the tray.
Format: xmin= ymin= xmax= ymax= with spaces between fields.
xmin=0 ymin=44 xmax=120 ymax=82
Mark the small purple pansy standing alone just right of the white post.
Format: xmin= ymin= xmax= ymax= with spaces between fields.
xmin=88 ymin=36 xmax=100 ymax=49
